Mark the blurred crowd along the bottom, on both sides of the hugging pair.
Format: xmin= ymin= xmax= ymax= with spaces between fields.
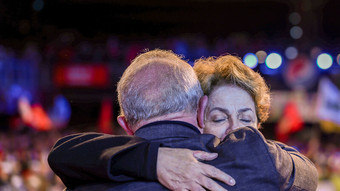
xmin=0 ymin=126 xmax=340 ymax=191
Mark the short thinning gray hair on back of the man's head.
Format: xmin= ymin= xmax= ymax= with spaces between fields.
xmin=117 ymin=49 xmax=203 ymax=126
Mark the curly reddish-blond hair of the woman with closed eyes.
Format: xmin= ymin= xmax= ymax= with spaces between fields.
xmin=194 ymin=55 xmax=270 ymax=124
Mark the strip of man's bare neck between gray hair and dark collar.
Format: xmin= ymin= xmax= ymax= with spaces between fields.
xmin=133 ymin=112 xmax=203 ymax=133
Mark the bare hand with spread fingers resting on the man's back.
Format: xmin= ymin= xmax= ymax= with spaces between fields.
xmin=157 ymin=147 xmax=235 ymax=191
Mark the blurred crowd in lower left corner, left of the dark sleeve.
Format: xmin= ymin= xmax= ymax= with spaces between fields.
xmin=0 ymin=129 xmax=64 ymax=191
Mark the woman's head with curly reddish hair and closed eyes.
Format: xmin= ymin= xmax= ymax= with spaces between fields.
xmin=194 ymin=55 xmax=270 ymax=139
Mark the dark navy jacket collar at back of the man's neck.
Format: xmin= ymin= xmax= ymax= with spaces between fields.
xmin=135 ymin=121 xmax=201 ymax=140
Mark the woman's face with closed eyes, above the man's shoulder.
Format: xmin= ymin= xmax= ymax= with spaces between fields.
xmin=204 ymin=85 xmax=257 ymax=139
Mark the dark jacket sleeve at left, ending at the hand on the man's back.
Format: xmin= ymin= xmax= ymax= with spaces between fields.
xmin=48 ymin=133 xmax=159 ymax=189
